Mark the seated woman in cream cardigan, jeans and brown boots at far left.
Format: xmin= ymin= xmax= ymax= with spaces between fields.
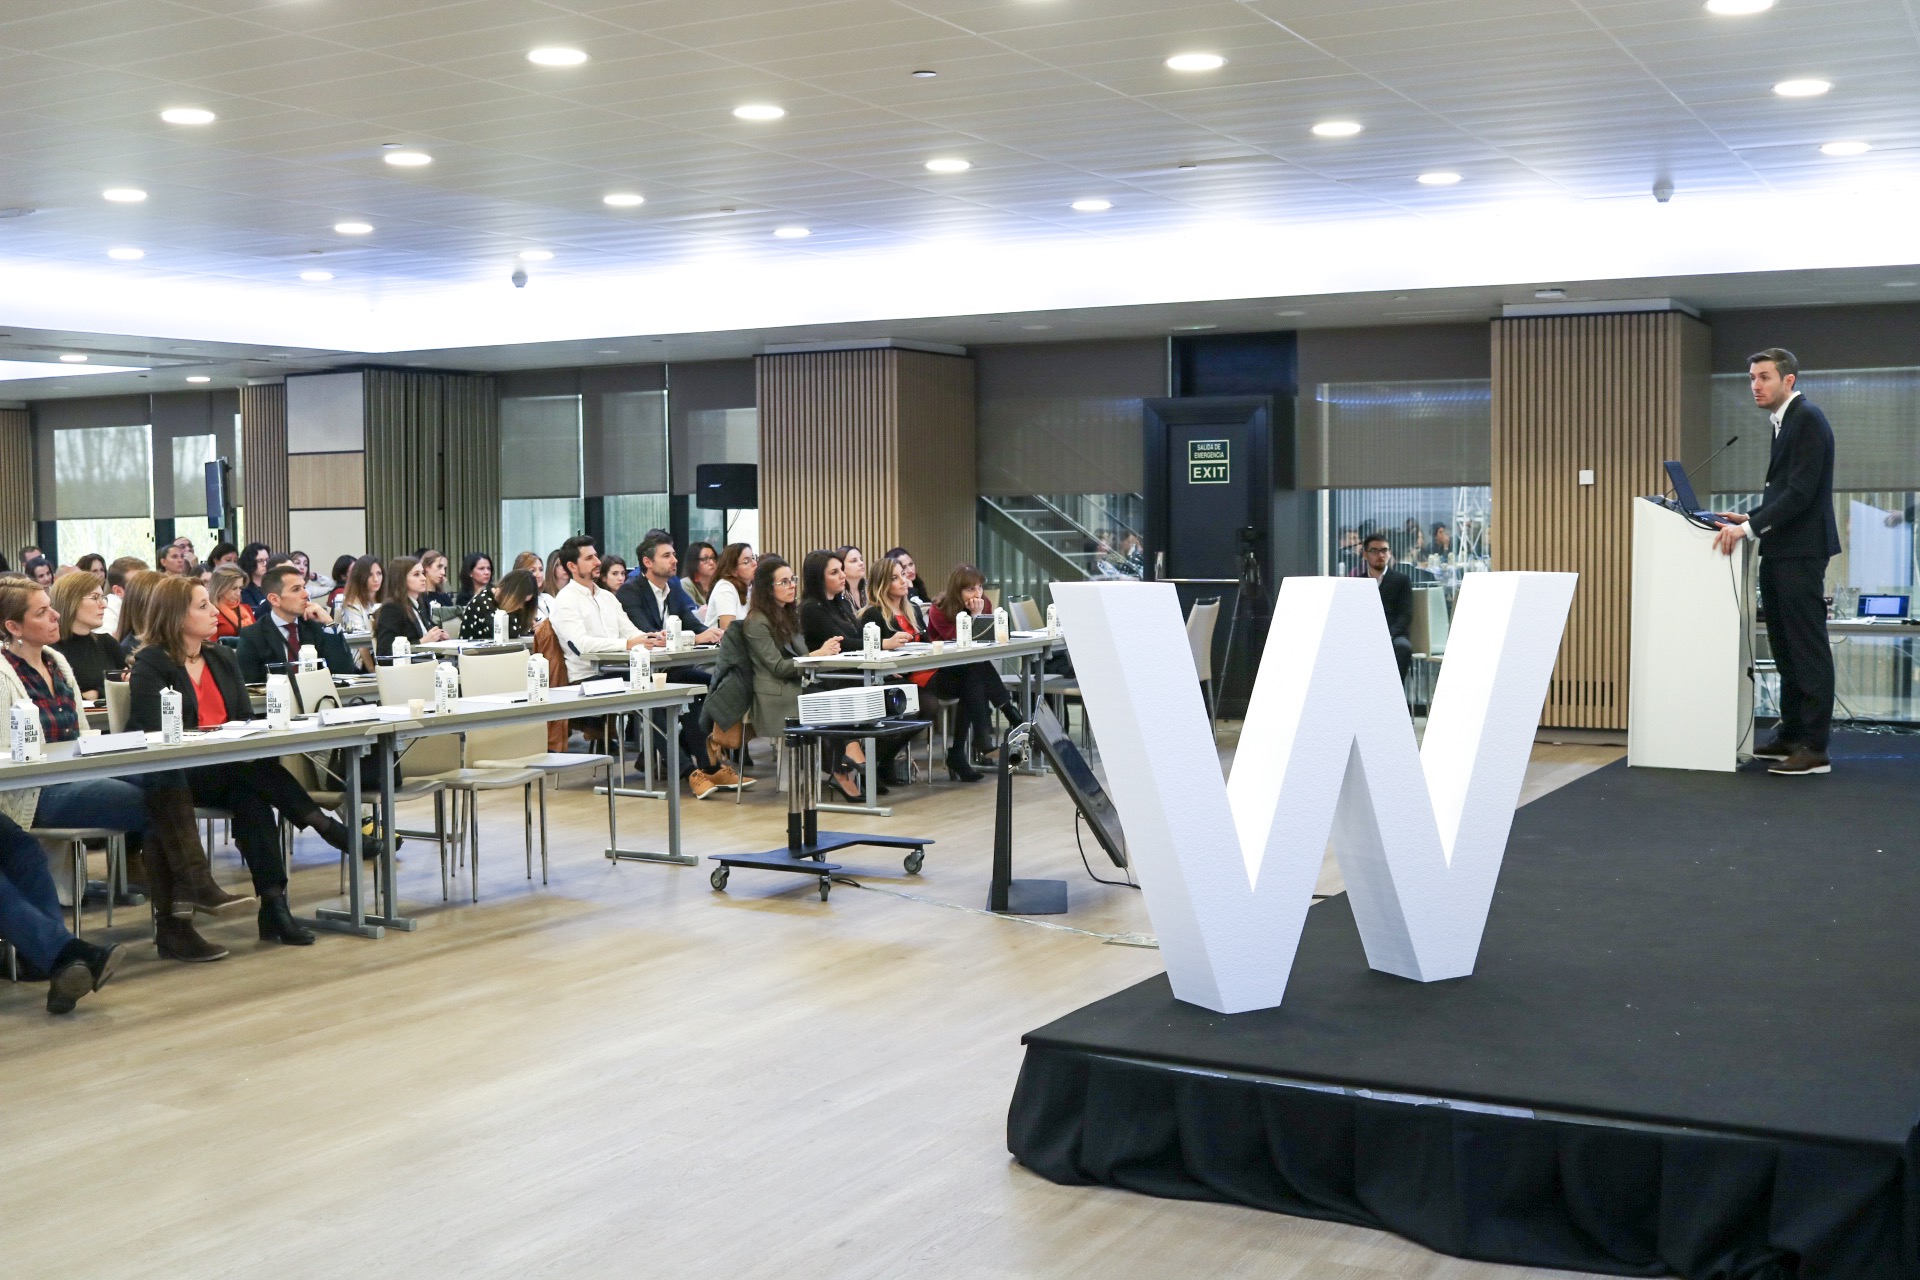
xmin=0 ymin=574 xmax=252 ymax=960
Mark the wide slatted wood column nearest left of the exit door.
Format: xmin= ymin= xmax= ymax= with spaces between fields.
xmin=755 ymin=349 xmax=975 ymax=585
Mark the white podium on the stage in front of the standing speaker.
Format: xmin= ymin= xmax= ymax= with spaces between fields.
xmin=1626 ymin=497 xmax=1753 ymax=771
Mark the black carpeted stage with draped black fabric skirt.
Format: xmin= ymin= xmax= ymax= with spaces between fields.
xmin=1008 ymin=735 xmax=1920 ymax=1278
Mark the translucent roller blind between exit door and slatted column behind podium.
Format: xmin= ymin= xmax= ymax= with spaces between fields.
xmin=1300 ymin=378 xmax=1494 ymax=489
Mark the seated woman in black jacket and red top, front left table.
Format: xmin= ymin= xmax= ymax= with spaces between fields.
xmin=129 ymin=578 xmax=348 ymax=946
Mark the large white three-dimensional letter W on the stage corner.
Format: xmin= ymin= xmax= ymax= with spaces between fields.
xmin=1054 ymin=574 xmax=1574 ymax=1013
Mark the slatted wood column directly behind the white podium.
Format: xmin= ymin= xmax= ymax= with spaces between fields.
xmin=1494 ymin=311 xmax=1709 ymax=729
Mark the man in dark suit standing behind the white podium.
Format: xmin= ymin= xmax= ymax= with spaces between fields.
xmin=1715 ymin=347 xmax=1839 ymax=775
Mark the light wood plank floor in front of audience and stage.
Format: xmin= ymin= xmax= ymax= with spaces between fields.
xmin=0 ymin=747 xmax=1620 ymax=1280
